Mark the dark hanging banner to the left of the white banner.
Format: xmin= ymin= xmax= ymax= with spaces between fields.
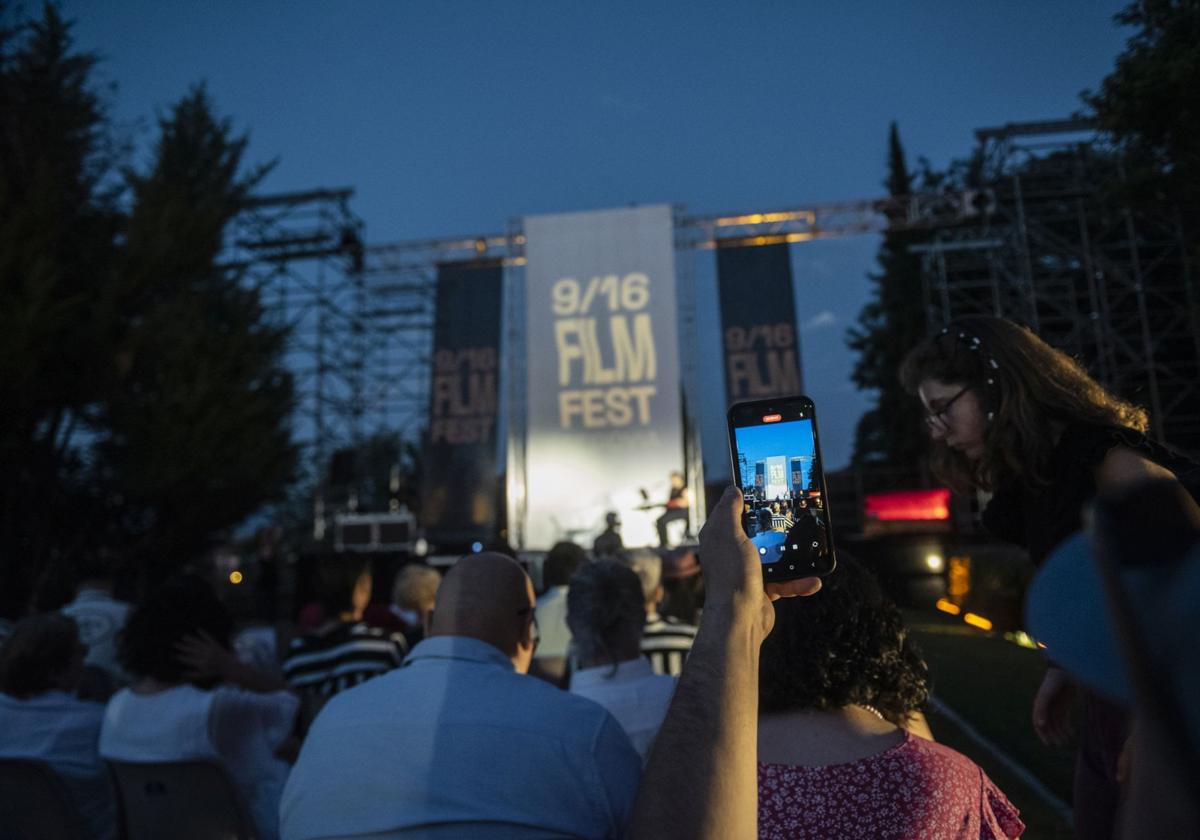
xmin=421 ymin=260 xmax=504 ymax=551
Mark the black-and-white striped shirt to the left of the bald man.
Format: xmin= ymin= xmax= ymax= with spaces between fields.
xmin=283 ymin=622 xmax=408 ymax=696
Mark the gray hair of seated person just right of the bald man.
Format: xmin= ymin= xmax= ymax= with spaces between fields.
xmin=566 ymin=560 xmax=646 ymax=671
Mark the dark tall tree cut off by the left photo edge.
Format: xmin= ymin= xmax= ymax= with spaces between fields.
xmin=0 ymin=4 xmax=119 ymax=616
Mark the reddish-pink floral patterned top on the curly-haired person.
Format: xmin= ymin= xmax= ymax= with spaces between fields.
xmin=758 ymin=733 xmax=1025 ymax=840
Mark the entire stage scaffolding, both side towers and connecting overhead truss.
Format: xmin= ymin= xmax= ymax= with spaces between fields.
xmin=227 ymin=120 xmax=1200 ymax=525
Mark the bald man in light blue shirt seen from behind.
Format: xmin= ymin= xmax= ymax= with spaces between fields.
xmin=280 ymin=553 xmax=641 ymax=840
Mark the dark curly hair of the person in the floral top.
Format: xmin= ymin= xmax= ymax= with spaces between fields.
xmin=758 ymin=551 xmax=929 ymax=726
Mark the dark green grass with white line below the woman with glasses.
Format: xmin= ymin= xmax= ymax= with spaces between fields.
xmin=905 ymin=611 xmax=1075 ymax=838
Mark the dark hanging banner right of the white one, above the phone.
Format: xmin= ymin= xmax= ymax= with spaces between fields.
xmin=716 ymin=240 xmax=804 ymax=403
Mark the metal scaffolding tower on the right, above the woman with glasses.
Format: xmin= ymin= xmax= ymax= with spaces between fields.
xmin=914 ymin=120 xmax=1200 ymax=450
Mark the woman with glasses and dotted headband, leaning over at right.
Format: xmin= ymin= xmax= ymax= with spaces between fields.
xmin=900 ymin=316 xmax=1195 ymax=838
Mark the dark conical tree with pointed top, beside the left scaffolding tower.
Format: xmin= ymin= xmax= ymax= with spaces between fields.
xmin=97 ymin=86 xmax=296 ymax=583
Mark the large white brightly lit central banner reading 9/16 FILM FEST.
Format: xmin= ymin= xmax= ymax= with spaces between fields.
xmin=523 ymin=205 xmax=684 ymax=548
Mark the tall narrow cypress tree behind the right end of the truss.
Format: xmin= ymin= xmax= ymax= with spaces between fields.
xmin=846 ymin=122 xmax=925 ymax=480
